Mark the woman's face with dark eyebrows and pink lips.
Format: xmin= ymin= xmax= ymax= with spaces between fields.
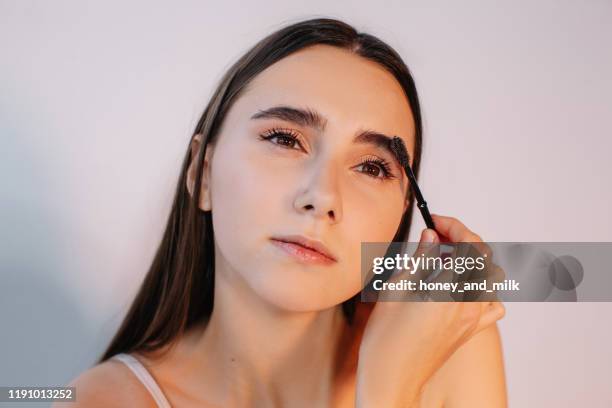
xmin=196 ymin=45 xmax=415 ymax=311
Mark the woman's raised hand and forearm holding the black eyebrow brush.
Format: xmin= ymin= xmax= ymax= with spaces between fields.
xmin=356 ymin=214 xmax=505 ymax=407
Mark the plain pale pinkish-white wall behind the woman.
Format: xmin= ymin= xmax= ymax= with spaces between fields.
xmin=0 ymin=0 xmax=612 ymax=407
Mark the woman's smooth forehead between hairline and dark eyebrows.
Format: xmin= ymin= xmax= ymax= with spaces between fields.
xmin=237 ymin=45 xmax=414 ymax=150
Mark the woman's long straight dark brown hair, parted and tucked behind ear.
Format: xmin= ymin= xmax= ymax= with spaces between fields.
xmin=98 ymin=18 xmax=422 ymax=363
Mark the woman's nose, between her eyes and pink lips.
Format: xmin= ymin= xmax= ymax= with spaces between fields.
xmin=294 ymin=158 xmax=342 ymax=224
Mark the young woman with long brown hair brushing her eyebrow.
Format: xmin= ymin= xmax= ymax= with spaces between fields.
xmin=58 ymin=19 xmax=506 ymax=407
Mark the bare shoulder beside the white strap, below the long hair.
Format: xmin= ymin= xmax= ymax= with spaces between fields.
xmin=53 ymin=360 xmax=156 ymax=408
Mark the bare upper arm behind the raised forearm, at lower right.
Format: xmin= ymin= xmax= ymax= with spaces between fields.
xmin=420 ymin=323 xmax=507 ymax=407
